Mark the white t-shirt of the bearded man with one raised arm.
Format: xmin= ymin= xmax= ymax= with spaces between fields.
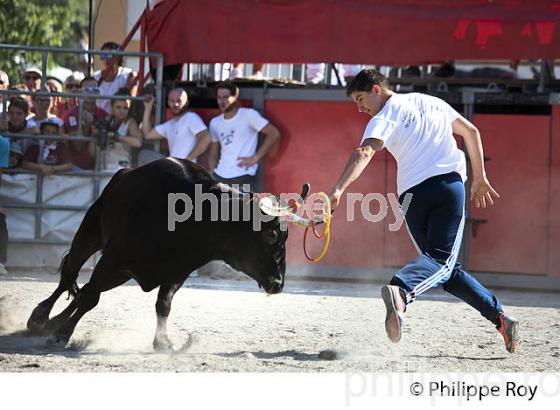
xmin=155 ymin=112 xmax=207 ymax=159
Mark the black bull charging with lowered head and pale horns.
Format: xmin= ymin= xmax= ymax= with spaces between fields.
xmin=27 ymin=158 xmax=294 ymax=349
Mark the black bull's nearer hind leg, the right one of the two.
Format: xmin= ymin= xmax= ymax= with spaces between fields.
xmin=48 ymin=256 xmax=130 ymax=344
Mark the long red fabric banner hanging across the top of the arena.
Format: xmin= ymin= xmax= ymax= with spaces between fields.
xmin=147 ymin=0 xmax=560 ymax=65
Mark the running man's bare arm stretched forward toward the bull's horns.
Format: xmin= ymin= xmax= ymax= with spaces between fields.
xmin=330 ymin=138 xmax=383 ymax=209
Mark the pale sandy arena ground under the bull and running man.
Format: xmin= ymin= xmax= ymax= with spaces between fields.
xmin=0 ymin=273 xmax=560 ymax=372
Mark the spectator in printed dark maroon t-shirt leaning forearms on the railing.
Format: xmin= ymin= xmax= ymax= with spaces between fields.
xmin=22 ymin=119 xmax=73 ymax=176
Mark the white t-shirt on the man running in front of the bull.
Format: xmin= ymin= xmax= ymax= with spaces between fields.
xmin=362 ymin=93 xmax=467 ymax=195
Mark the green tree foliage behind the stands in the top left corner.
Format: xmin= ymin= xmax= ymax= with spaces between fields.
xmin=0 ymin=0 xmax=89 ymax=82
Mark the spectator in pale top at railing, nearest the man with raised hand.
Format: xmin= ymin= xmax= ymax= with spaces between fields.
xmin=94 ymin=88 xmax=142 ymax=171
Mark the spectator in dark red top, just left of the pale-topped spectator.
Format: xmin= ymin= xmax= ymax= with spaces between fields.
xmin=64 ymin=77 xmax=109 ymax=170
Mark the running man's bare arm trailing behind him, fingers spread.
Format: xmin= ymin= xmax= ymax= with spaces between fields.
xmin=451 ymin=116 xmax=500 ymax=208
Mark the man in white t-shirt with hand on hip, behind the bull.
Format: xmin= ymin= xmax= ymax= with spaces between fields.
xmin=208 ymin=81 xmax=280 ymax=190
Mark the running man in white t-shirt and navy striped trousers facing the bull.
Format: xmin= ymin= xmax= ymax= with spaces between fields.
xmin=330 ymin=69 xmax=519 ymax=353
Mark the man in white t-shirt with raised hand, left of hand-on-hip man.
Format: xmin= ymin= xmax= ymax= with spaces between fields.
xmin=142 ymin=87 xmax=210 ymax=162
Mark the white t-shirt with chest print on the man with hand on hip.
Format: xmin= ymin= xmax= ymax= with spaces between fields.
xmin=210 ymin=108 xmax=268 ymax=178
